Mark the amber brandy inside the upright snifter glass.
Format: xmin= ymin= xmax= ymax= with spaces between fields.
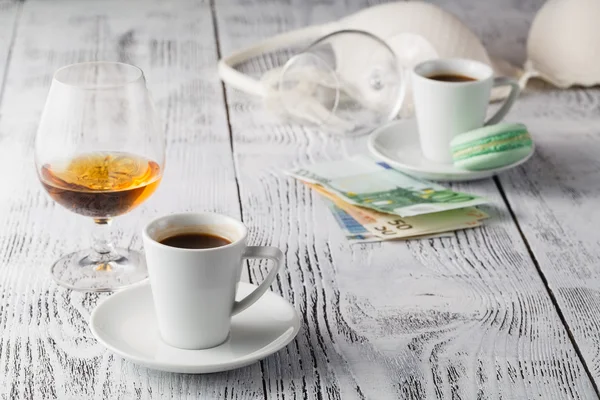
xmin=40 ymin=152 xmax=162 ymax=220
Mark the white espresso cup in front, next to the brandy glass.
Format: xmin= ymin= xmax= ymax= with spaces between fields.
xmin=143 ymin=213 xmax=284 ymax=349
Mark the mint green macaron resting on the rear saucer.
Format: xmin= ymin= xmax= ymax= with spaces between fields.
xmin=450 ymin=123 xmax=533 ymax=171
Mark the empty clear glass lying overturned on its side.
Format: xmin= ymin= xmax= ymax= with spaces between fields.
xmin=271 ymin=30 xmax=406 ymax=136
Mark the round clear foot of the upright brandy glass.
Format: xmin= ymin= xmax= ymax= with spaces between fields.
xmin=51 ymin=249 xmax=148 ymax=292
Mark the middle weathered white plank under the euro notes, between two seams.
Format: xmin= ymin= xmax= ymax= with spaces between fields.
xmin=216 ymin=0 xmax=597 ymax=399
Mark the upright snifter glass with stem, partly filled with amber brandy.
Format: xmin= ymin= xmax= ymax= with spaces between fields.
xmin=35 ymin=62 xmax=165 ymax=291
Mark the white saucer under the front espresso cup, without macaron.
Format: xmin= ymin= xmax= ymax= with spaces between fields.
xmin=90 ymin=282 xmax=300 ymax=374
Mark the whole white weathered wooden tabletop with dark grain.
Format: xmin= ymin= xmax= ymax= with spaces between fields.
xmin=0 ymin=0 xmax=600 ymax=400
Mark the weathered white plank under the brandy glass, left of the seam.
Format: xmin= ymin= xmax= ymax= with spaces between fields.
xmin=0 ymin=0 xmax=263 ymax=399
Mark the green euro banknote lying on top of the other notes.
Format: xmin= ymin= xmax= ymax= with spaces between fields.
xmin=287 ymin=155 xmax=487 ymax=217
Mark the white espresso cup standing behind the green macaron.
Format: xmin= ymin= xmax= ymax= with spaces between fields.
xmin=412 ymin=59 xmax=520 ymax=163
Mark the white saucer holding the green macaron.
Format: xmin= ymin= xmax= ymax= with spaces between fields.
xmin=368 ymin=119 xmax=535 ymax=182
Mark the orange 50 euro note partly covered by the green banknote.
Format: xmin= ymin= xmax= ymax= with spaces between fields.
xmin=306 ymin=184 xmax=488 ymax=240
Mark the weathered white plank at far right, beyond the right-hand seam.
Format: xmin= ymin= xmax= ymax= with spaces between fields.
xmin=500 ymin=85 xmax=600 ymax=385
